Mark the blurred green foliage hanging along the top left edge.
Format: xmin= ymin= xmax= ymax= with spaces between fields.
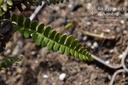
xmin=0 ymin=0 xmax=69 ymax=17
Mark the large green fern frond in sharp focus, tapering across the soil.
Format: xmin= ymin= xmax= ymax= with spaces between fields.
xmin=11 ymin=15 xmax=93 ymax=61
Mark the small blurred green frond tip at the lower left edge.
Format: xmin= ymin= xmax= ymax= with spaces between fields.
xmin=0 ymin=57 xmax=22 ymax=70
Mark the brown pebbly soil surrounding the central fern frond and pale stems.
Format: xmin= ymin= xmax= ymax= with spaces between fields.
xmin=0 ymin=0 xmax=128 ymax=85
